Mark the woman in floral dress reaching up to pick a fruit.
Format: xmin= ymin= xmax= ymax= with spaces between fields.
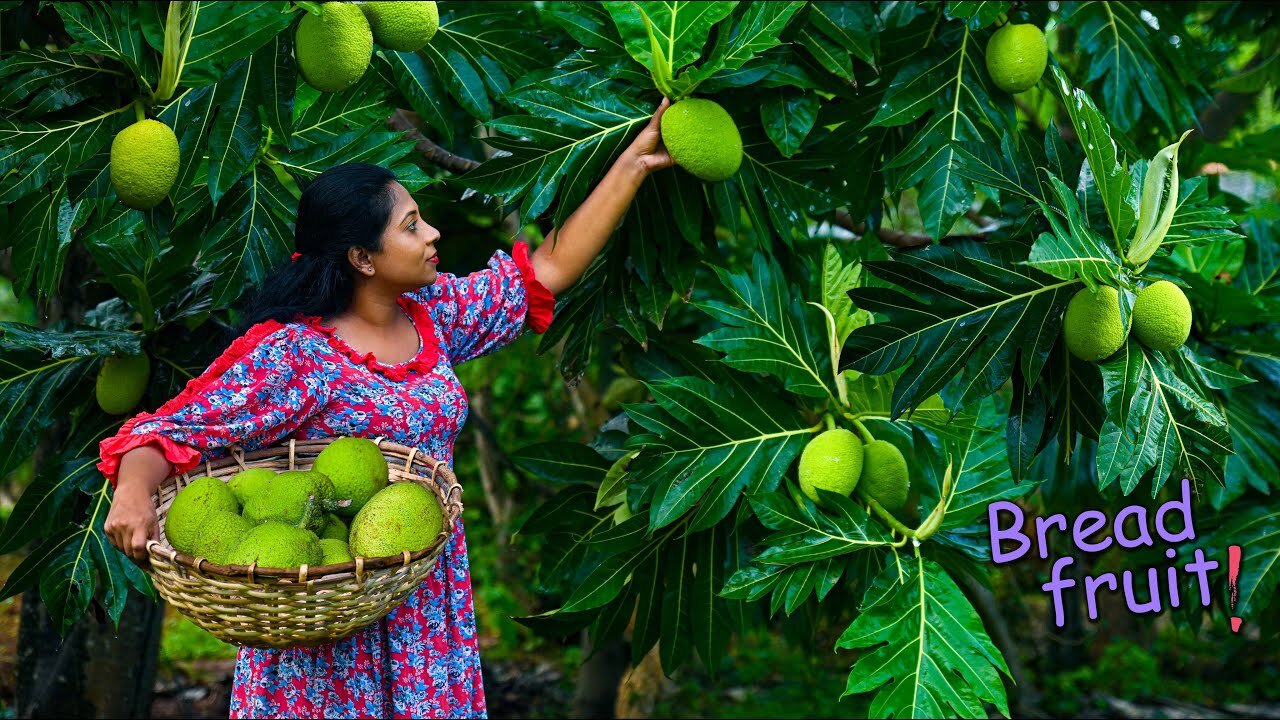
xmin=99 ymin=100 xmax=672 ymax=717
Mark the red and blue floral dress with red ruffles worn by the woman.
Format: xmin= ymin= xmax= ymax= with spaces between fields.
xmin=99 ymin=242 xmax=554 ymax=717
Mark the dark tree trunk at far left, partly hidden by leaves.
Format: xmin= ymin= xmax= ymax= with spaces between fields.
xmin=17 ymin=245 xmax=164 ymax=717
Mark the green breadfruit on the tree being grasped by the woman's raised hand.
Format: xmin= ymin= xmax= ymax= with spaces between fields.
xmin=662 ymin=97 xmax=742 ymax=182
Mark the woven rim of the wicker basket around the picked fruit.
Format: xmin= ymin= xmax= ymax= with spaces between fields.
xmin=147 ymin=436 xmax=462 ymax=583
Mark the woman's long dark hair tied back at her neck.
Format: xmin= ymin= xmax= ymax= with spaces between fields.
xmin=228 ymin=163 xmax=396 ymax=345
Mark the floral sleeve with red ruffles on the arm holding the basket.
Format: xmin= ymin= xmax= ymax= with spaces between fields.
xmin=97 ymin=320 xmax=328 ymax=487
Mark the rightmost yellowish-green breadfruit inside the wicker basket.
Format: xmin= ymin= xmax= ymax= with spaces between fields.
xmin=351 ymin=482 xmax=444 ymax=557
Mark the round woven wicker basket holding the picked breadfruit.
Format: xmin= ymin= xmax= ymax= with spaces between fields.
xmin=147 ymin=438 xmax=462 ymax=648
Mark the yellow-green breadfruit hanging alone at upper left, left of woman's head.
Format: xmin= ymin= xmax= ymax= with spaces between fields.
xmin=110 ymin=119 xmax=178 ymax=210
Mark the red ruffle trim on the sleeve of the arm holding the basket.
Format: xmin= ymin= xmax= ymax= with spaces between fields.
xmin=97 ymin=320 xmax=284 ymax=488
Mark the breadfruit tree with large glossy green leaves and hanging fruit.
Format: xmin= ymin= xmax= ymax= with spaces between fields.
xmin=0 ymin=1 xmax=1280 ymax=716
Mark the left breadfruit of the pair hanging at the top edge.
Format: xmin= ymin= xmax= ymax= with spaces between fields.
xmin=294 ymin=3 xmax=374 ymax=92
